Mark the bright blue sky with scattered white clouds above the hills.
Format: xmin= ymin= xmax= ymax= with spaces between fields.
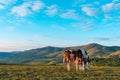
xmin=0 ymin=0 xmax=120 ymax=51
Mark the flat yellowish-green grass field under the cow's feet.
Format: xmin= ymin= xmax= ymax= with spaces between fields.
xmin=0 ymin=65 xmax=120 ymax=80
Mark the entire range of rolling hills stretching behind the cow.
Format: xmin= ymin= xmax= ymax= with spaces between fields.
xmin=0 ymin=43 xmax=120 ymax=65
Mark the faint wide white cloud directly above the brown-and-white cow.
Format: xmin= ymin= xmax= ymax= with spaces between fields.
xmin=60 ymin=10 xmax=80 ymax=19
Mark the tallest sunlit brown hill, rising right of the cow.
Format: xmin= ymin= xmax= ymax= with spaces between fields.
xmin=77 ymin=43 xmax=120 ymax=58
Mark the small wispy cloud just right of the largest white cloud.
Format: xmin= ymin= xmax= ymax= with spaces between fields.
xmin=45 ymin=5 xmax=58 ymax=16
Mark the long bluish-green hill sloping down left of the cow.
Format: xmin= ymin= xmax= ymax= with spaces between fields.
xmin=2 ymin=46 xmax=67 ymax=63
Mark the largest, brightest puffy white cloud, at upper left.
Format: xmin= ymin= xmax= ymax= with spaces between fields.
xmin=11 ymin=1 xmax=45 ymax=16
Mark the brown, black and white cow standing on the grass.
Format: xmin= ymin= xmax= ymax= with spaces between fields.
xmin=63 ymin=49 xmax=90 ymax=71
